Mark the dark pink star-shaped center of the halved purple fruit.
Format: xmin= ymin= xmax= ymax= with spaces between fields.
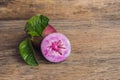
xmin=49 ymin=40 xmax=65 ymax=55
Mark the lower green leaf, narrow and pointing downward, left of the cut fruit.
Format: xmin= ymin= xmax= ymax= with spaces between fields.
xmin=19 ymin=38 xmax=38 ymax=66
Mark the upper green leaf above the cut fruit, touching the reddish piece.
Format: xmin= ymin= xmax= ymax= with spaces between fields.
xmin=25 ymin=15 xmax=49 ymax=36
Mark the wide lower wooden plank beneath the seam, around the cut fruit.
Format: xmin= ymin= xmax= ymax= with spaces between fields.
xmin=0 ymin=20 xmax=120 ymax=80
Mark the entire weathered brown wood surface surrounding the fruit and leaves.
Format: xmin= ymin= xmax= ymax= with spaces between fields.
xmin=0 ymin=0 xmax=120 ymax=80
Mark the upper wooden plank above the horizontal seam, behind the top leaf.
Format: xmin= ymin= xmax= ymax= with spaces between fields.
xmin=0 ymin=0 xmax=120 ymax=20
